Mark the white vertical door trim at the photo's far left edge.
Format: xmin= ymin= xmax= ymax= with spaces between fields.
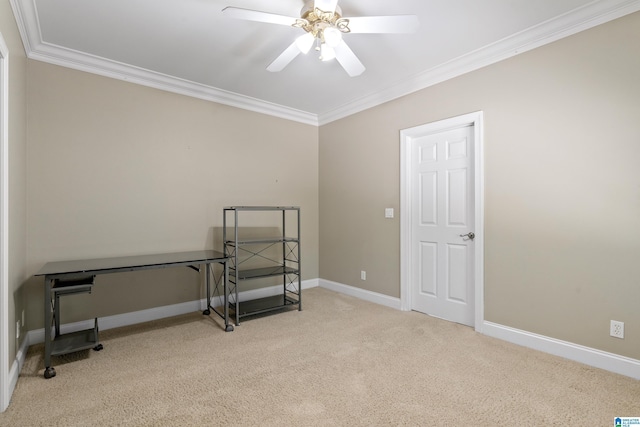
xmin=0 ymin=29 xmax=13 ymax=412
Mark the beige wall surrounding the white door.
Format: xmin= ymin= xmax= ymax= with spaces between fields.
xmin=320 ymin=13 xmax=640 ymax=359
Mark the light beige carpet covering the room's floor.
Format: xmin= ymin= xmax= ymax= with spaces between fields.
xmin=0 ymin=288 xmax=640 ymax=427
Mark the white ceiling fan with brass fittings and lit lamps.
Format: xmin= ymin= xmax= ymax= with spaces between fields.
xmin=222 ymin=0 xmax=419 ymax=77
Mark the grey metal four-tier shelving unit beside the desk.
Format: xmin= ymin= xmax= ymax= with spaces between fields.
xmin=223 ymin=206 xmax=302 ymax=325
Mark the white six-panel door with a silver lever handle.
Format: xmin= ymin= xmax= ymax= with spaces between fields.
xmin=408 ymin=125 xmax=475 ymax=326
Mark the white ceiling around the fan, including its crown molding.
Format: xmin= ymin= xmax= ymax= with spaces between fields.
xmin=10 ymin=0 xmax=640 ymax=125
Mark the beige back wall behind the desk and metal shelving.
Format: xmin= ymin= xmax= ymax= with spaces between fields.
xmin=25 ymin=61 xmax=318 ymax=330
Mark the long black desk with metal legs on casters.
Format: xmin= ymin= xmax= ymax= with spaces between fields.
xmin=36 ymin=250 xmax=233 ymax=378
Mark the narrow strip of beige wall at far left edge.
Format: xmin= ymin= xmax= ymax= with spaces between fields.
xmin=0 ymin=0 xmax=28 ymax=374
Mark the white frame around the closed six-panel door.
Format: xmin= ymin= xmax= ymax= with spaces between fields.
xmin=400 ymin=111 xmax=484 ymax=332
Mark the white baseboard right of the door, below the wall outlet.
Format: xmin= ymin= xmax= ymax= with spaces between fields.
xmin=483 ymin=322 xmax=640 ymax=379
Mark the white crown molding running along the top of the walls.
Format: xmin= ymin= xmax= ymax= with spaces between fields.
xmin=10 ymin=0 xmax=640 ymax=126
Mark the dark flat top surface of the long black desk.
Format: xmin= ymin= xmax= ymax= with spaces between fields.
xmin=36 ymin=250 xmax=226 ymax=276
